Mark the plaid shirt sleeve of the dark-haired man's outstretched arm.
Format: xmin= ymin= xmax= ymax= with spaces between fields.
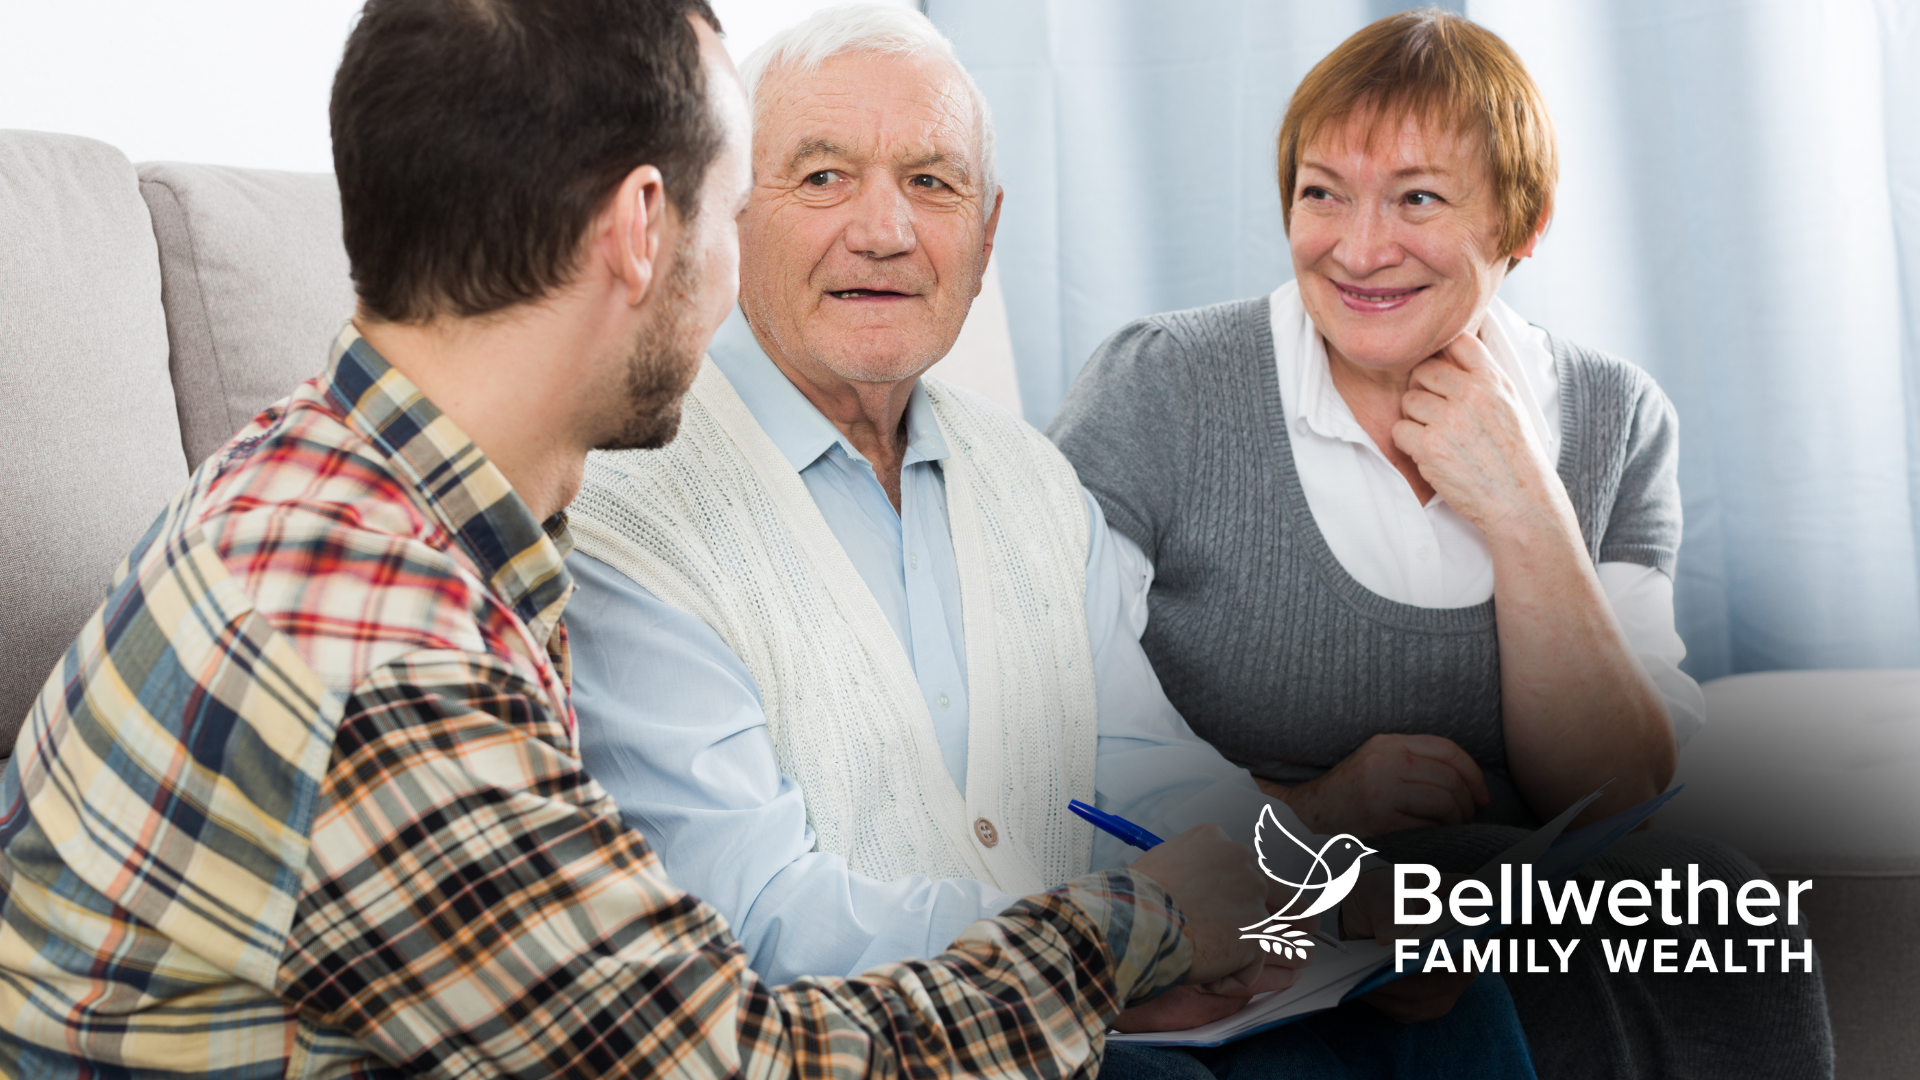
xmin=276 ymin=650 xmax=1190 ymax=1080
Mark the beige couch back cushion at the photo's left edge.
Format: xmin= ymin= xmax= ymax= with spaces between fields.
xmin=0 ymin=131 xmax=186 ymax=753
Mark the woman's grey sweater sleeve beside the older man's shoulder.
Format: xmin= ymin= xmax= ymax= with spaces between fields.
xmin=1046 ymin=319 xmax=1194 ymax=561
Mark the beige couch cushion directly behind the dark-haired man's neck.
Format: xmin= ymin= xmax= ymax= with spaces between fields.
xmin=140 ymin=161 xmax=353 ymax=465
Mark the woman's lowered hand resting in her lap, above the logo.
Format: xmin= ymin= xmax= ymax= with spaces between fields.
xmin=1260 ymin=734 xmax=1488 ymax=836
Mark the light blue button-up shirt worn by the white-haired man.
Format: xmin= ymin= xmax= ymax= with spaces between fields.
xmin=566 ymin=315 xmax=1292 ymax=984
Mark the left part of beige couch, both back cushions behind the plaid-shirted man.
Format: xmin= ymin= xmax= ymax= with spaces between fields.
xmin=0 ymin=131 xmax=353 ymax=753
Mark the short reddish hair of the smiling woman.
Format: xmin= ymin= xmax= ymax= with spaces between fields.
xmin=1279 ymin=8 xmax=1559 ymax=263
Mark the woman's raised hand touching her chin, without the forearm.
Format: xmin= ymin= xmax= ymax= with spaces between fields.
xmin=1392 ymin=332 xmax=1580 ymax=540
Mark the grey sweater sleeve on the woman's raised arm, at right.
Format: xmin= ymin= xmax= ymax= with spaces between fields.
xmin=1597 ymin=375 xmax=1680 ymax=578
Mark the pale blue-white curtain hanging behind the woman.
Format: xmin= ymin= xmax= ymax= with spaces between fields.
xmin=927 ymin=0 xmax=1920 ymax=678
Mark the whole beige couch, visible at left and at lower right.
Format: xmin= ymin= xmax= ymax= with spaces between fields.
xmin=0 ymin=131 xmax=1920 ymax=1078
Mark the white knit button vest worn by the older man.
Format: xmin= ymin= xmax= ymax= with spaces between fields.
xmin=570 ymin=361 xmax=1096 ymax=894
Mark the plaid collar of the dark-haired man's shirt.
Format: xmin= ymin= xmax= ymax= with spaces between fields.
xmin=321 ymin=323 xmax=574 ymax=648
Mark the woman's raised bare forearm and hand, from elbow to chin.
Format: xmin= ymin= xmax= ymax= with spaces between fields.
xmin=1392 ymin=334 xmax=1678 ymax=824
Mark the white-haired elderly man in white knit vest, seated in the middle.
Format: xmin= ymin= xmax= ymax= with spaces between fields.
xmin=568 ymin=6 xmax=1524 ymax=1076
